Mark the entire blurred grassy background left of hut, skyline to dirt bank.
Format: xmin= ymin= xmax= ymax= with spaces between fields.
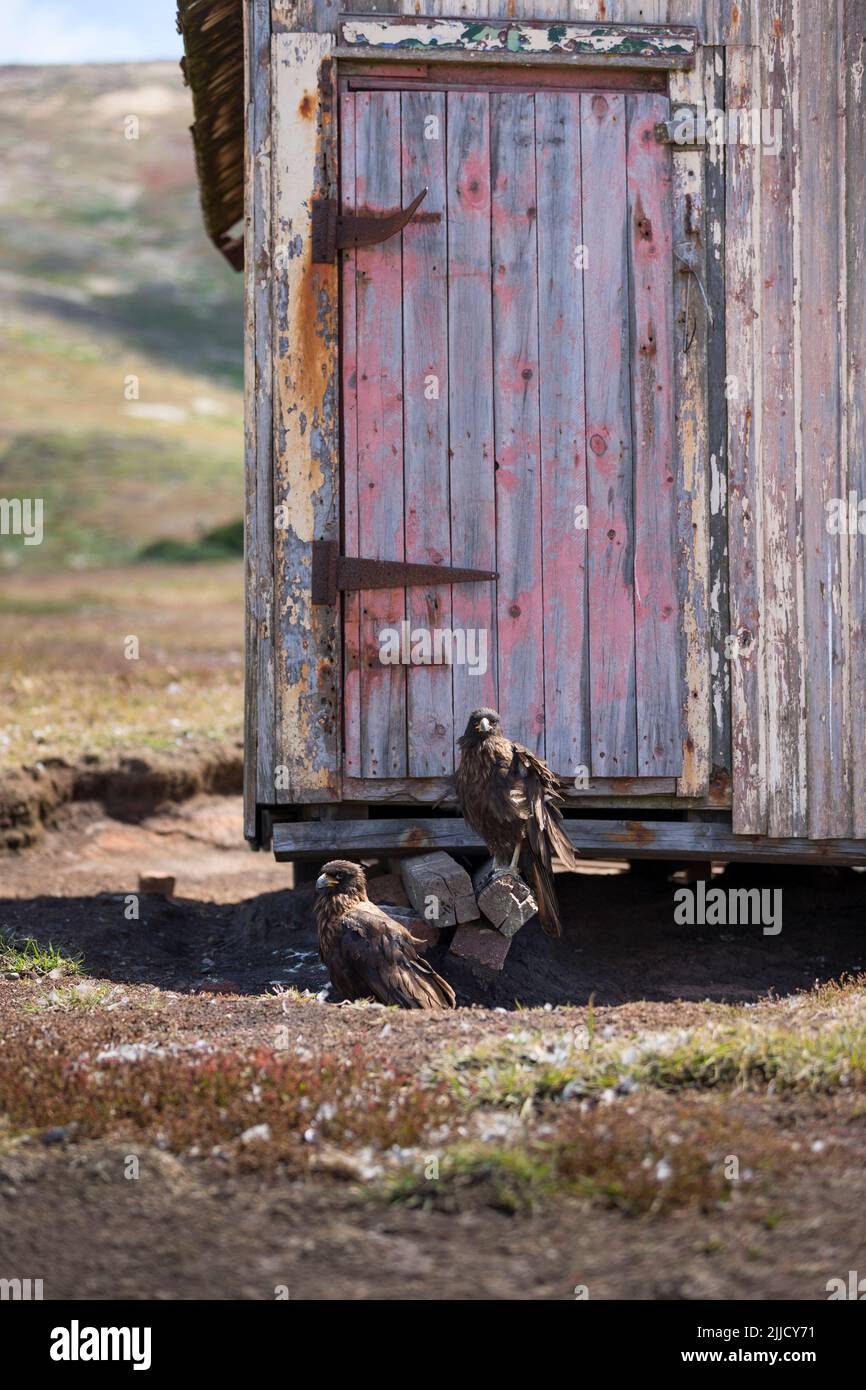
xmin=0 ymin=63 xmax=243 ymax=778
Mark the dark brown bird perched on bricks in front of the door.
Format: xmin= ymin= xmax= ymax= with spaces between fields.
xmin=455 ymin=709 xmax=577 ymax=937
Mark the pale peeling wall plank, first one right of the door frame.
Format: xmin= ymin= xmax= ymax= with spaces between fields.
xmin=726 ymin=49 xmax=767 ymax=834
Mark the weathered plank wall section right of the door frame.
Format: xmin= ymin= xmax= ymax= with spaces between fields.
xmin=726 ymin=0 xmax=866 ymax=840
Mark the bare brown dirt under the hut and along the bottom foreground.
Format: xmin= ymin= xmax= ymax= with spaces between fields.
xmin=0 ymin=796 xmax=866 ymax=1300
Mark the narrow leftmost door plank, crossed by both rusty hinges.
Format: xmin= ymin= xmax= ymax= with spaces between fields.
xmin=339 ymin=92 xmax=361 ymax=777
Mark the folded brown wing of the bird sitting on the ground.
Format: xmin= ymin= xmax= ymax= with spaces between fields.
xmin=335 ymin=902 xmax=456 ymax=1009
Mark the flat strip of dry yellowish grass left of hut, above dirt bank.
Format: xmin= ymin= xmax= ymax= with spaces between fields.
xmin=0 ymin=563 xmax=243 ymax=769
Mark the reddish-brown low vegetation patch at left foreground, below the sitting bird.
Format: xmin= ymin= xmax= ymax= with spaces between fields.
xmin=0 ymin=1034 xmax=455 ymax=1172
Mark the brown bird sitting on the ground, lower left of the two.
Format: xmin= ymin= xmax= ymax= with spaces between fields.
xmin=316 ymin=859 xmax=457 ymax=1009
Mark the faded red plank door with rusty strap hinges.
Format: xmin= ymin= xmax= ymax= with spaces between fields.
xmin=341 ymin=90 xmax=683 ymax=778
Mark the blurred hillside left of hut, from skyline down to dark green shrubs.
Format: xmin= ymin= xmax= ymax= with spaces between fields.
xmin=0 ymin=63 xmax=243 ymax=571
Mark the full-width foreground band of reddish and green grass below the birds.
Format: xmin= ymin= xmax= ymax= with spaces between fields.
xmin=0 ymin=980 xmax=866 ymax=1220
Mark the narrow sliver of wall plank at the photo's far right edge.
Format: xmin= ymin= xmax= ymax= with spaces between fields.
xmin=844 ymin=0 xmax=866 ymax=838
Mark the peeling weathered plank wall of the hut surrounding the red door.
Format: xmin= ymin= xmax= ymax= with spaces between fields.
xmin=247 ymin=0 xmax=866 ymax=838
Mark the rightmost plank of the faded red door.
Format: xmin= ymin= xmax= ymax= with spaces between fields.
xmin=626 ymin=93 xmax=683 ymax=777
